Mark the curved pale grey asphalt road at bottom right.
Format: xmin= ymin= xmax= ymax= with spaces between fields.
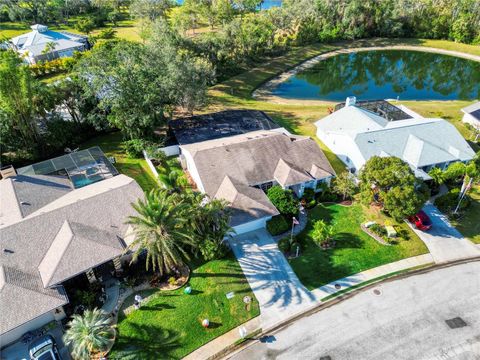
xmin=231 ymin=262 xmax=480 ymax=360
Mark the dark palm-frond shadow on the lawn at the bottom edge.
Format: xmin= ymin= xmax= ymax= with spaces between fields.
xmin=109 ymin=323 xmax=181 ymax=360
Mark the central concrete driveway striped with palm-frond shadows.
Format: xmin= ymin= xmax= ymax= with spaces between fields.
xmin=229 ymin=229 xmax=316 ymax=329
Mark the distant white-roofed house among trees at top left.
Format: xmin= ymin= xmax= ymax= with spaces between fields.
xmin=8 ymin=24 xmax=90 ymax=64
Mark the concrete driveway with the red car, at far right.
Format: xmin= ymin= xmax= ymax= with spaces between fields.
xmin=409 ymin=202 xmax=480 ymax=264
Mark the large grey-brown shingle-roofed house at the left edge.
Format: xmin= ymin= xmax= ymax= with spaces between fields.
xmin=0 ymin=150 xmax=143 ymax=348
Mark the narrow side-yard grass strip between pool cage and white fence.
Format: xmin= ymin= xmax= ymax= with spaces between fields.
xmin=81 ymin=131 xmax=157 ymax=191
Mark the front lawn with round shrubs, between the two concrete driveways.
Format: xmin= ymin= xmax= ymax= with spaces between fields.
xmin=290 ymin=203 xmax=428 ymax=289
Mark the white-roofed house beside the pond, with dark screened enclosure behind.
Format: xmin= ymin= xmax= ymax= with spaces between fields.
xmin=315 ymin=97 xmax=475 ymax=180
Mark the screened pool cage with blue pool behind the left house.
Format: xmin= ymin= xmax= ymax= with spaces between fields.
xmin=17 ymin=146 xmax=118 ymax=188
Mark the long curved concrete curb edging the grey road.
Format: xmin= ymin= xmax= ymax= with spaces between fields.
xmin=216 ymin=256 xmax=480 ymax=360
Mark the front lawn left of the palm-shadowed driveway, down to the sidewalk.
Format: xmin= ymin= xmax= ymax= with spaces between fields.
xmin=109 ymin=256 xmax=260 ymax=359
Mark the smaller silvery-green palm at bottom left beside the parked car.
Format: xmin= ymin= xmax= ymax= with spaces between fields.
xmin=63 ymin=308 xmax=115 ymax=359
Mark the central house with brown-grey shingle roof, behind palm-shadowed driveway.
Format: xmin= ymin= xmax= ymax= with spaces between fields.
xmin=180 ymin=128 xmax=335 ymax=234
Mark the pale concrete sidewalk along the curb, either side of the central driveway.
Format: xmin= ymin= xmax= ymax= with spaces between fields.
xmin=179 ymin=254 xmax=434 ymax=360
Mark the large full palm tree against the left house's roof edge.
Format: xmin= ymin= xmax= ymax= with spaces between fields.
xmin=127 ymin=190 xmax=195 ymax=275
